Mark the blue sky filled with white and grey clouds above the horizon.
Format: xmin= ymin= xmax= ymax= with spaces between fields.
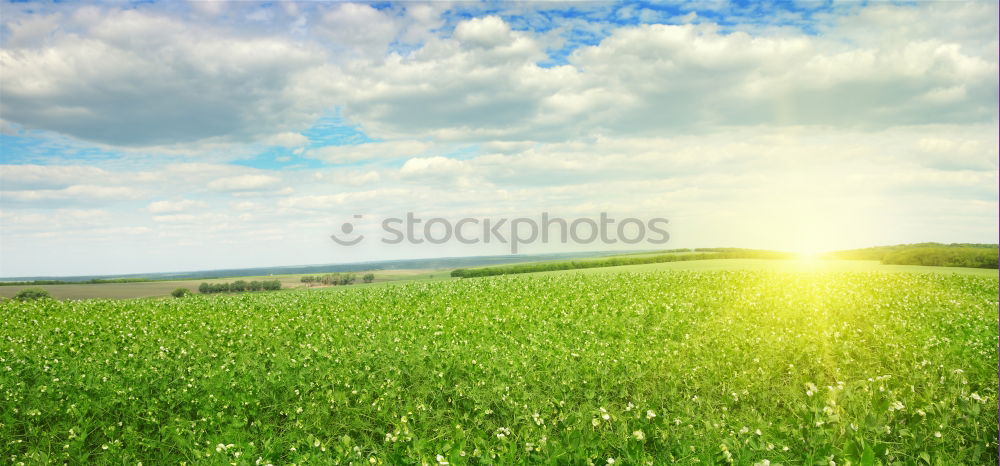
xmin=0 ymin=1 xmax=998 ymax=277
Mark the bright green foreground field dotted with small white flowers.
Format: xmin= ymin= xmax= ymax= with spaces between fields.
xmin=0 ymin=261 xmax=998 ymax=465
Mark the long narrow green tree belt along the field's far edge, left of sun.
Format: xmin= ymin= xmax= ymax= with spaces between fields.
xmin=451 ymin=248 xmax=795 ymax=278
